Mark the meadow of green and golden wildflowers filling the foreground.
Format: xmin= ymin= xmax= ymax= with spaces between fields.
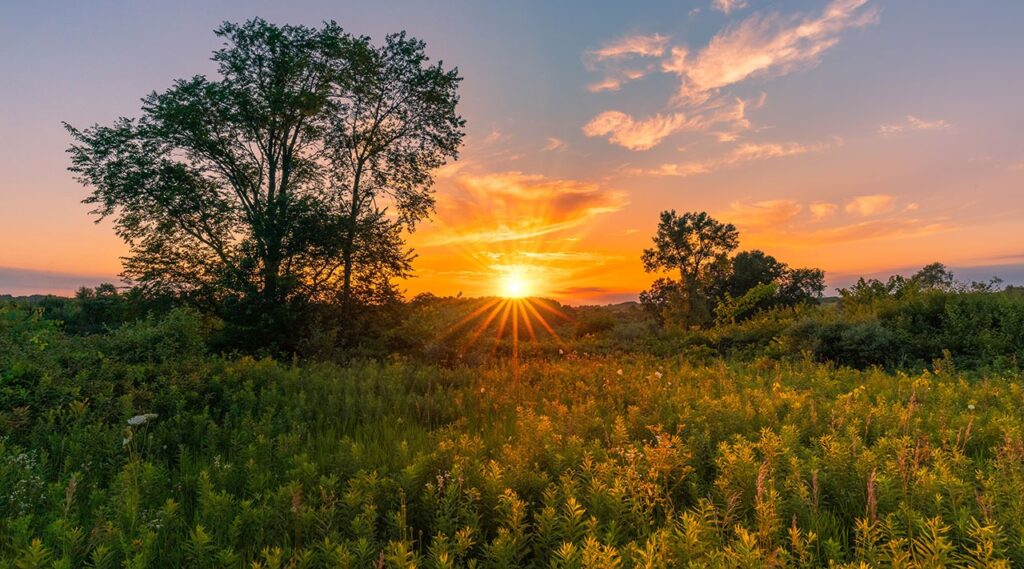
xmin=0 ymin=306 xmax=1024 ymax=568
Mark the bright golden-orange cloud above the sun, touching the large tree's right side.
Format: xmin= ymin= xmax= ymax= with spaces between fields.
xmin=426 ymin=171 xmax=627 ymax=246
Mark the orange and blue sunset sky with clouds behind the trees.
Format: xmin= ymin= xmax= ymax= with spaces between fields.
xmin=0 ymin=0 xmax=1024 ymax=303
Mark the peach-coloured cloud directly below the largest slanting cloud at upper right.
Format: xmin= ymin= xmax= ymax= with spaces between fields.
xmin=583 ymin=98 xmax=751 ymax=150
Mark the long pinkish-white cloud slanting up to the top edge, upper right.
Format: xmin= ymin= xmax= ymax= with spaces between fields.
xmin=662 ymin=0 xmax=878 ymax=101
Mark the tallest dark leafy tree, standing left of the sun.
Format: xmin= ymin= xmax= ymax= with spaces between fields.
xmin=68 ymin=19 xmax=465 ymax=341
